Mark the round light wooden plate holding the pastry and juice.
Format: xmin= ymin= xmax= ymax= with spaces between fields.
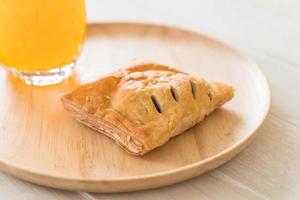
xmin=0 ymin=23 xmax=270 ymax=192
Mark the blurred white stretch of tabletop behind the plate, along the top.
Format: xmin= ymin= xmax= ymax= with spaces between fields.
xmin=87 ymin=0 xmax=300 ymax=65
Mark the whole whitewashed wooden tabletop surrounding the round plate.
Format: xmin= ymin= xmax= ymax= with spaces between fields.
xmin=0 ymin=0 xmax=300 ymax=200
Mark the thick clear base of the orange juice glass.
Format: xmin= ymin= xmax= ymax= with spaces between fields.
xmin=6 ymin=62 xmax=75 ymax=86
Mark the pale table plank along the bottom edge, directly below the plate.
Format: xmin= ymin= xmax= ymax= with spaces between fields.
xmin=93 ymin=170 xmax=266 ymax=200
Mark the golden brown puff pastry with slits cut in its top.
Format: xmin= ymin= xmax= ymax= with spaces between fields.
xmin=62 ymin=64 xmax=234 ymax=155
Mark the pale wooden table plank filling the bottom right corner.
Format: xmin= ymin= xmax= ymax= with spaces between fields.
xmin=220 ymin=115 xmax=300 ymax=199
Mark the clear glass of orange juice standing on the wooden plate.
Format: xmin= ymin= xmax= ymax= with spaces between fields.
xmin=0 ymin=0 xmax=86 ymax=85
